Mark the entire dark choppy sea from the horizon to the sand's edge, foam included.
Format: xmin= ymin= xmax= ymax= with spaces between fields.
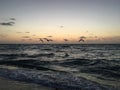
xmin=0 ymin=44 xmax=120 ymax=90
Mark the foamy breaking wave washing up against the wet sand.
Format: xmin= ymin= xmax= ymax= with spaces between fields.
xmin=0 ymin=68 xmax=112 ymax=90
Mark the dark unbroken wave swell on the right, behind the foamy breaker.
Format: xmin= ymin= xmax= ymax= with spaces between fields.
xmin=60 ymin=59 xmax=120 ymax=80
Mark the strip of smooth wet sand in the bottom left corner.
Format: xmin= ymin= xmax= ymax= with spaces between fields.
xmin=0 ymin=77 xmax=55 ymax=90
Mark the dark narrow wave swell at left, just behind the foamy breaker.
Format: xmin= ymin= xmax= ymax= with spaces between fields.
xmin=0 ymin=59 xmax=55 ymax=71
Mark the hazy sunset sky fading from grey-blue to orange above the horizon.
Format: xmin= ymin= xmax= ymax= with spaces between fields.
xmin=0 ymin=0 xmax=120 ymax=44
